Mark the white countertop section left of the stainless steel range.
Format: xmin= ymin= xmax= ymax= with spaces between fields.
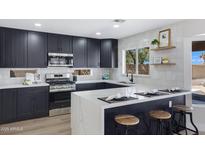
xmin=0 ymin=82 xmax=49 ymax=89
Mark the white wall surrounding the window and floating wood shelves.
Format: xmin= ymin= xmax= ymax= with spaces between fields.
xmin=113 ymin=20 xmax=205 ymax=88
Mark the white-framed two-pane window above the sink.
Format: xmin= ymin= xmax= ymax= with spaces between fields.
xmin=123 ymin=47 xmax=150 ymax=75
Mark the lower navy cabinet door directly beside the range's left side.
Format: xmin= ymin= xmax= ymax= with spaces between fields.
xmin=32 ymin=87 xmax=49 ymax=117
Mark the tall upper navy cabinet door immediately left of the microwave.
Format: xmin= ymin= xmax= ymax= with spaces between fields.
xmin=28 ymin=32 xmax=47 ymax=68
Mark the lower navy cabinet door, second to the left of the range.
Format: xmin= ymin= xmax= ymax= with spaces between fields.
xmin=17 ymin=88 xmax=34 ymax=120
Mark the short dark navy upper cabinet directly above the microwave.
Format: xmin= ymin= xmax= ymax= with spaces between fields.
xmin=48 ymin=33 xmax=73 ymax=53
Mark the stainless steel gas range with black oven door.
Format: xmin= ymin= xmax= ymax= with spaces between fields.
xmin=46 ymin=73 xmax=76 ymax=116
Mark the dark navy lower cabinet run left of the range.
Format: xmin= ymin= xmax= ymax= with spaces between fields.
xmin=0 ymin=87 xmax=49 ymax=123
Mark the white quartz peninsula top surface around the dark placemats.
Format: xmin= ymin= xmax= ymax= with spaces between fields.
xmin=72 ymin=80 xmax=191 ymax=109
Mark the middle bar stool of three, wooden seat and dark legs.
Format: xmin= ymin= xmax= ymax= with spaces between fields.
xmin=149 ymin=110 xmax=172 ymax=135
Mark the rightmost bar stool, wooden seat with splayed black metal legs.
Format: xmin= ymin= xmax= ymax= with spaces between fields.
xmin=173 ymin=105 xmax=199 ymax=135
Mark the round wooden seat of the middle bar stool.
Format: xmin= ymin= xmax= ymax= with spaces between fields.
xmin=149 ymin=110 xmax=172 ymax=120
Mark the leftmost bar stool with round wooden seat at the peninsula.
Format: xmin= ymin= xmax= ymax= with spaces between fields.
xmin=115 ymin=114 xmax=140 ymax=135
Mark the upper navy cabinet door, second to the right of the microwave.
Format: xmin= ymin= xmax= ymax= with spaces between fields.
xmin=87 ymin=39 xmax=100 ymax=68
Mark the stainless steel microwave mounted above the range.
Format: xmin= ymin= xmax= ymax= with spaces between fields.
xmin=48 ymin=53 xmax=73 ymax=67
